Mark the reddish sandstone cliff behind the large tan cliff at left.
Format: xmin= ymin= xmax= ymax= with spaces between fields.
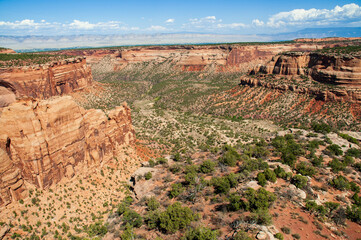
xmin=0 ymin=57 xmax=92 ymax=99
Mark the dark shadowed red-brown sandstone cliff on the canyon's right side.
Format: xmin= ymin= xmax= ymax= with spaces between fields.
xmin=251 ymin=52 xmax=361 ymax=88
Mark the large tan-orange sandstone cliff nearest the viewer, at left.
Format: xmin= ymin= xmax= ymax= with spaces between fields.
xmin=0 ymin=96 xmax=135 ymax=205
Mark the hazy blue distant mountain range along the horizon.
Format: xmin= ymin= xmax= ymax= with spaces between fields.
xmin=0 ymin=27 xmax=361 ymax=51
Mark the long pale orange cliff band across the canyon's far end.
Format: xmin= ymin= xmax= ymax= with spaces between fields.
xmin=52 ymin=43 xmax=342 ymax=71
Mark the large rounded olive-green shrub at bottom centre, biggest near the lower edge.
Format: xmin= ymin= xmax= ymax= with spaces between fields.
xmin=158 ymin=202 xmax=195 ymax=233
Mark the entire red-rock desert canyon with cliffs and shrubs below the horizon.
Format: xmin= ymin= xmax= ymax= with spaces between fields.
xmin=0 ymin=37 xmax=361 ymax=240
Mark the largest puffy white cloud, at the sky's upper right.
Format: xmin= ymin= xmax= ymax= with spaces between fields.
xmin=267 ymin=3 xmax=361 ymax=27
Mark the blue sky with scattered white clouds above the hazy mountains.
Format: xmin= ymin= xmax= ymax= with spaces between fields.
xmin=0 ymin=0 xmax=361 ymax=36
